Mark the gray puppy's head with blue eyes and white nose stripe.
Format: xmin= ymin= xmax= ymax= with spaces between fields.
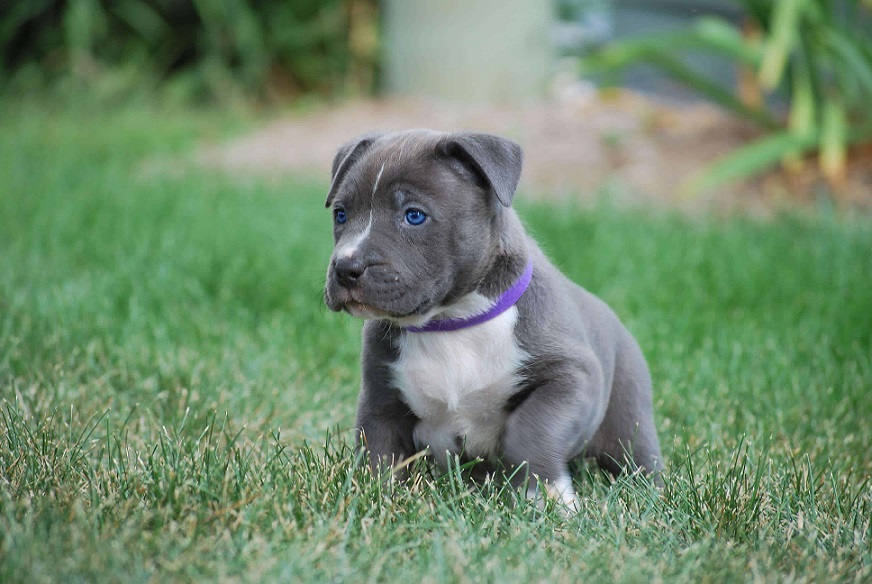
xmin=324 ymin=130 xmax=522 ymax=325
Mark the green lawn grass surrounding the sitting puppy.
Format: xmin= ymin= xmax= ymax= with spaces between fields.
xmin=0 ymin=103 xmax=872 ymax=582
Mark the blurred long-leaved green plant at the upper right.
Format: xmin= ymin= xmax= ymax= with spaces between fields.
xmin=583 ymin=0 xmax=872 ymax=191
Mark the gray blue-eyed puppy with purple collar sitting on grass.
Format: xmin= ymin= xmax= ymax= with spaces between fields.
xmin=325 ymin=130 xmax=662 ymax=508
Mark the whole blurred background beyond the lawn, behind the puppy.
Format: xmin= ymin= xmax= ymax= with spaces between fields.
xmin=0 ymin=0 xmax=872 ymax=206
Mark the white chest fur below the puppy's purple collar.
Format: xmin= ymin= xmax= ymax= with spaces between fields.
xmin=393 ymin=296 xmax=527 ymax=461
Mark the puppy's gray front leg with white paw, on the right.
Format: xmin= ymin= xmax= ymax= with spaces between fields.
xmin=503 ymin=357 xmax=606 ymax=510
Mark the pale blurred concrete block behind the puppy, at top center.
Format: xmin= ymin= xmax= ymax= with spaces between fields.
xmin=382 ymin=0 xmax=552 ymax=103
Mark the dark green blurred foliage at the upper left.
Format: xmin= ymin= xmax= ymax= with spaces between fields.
xmin=0 ymin=0 xmax=376 ymax=99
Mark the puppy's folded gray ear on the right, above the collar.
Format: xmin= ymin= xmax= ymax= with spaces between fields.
xmin=437 ymin=132 xmax=524 ymax=207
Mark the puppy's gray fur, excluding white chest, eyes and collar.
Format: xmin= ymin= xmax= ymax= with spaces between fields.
xmin=325 ymin=130 xmax=662 ymax=498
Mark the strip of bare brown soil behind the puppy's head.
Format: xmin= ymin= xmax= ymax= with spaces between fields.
xmin=199 ymin=86 xmax=872 ymax=215
